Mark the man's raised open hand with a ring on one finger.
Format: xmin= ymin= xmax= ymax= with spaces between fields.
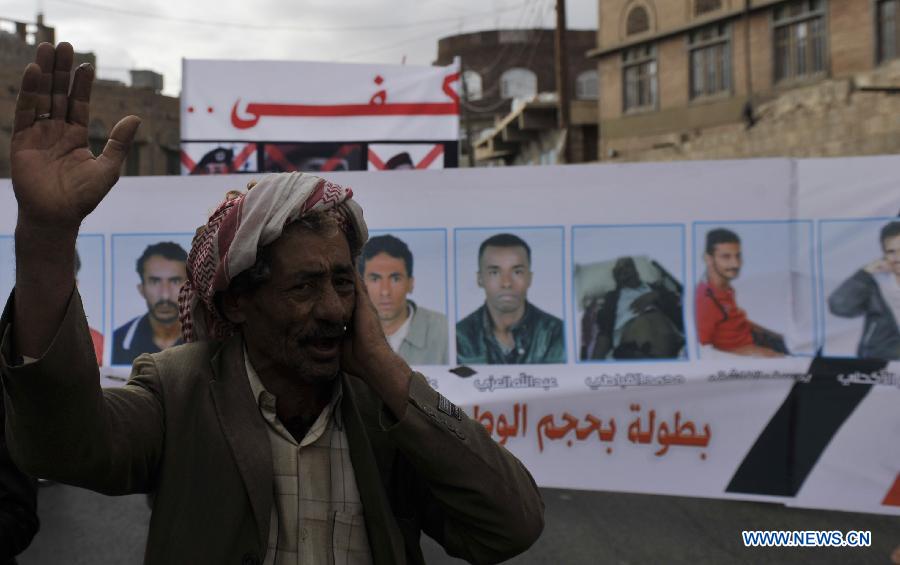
xmin=10 ymin=43 xmax=140 ymax=229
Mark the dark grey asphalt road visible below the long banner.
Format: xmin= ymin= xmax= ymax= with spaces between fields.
xmin=19 ymin=485 xmax=900 ymax=565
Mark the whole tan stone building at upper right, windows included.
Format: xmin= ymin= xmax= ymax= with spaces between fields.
xmin=589 ymin=0 xmax=900 ymax=161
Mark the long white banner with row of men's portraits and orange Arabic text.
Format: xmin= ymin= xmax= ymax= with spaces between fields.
xmin=0 ymin=157 xmax=900 ymax=515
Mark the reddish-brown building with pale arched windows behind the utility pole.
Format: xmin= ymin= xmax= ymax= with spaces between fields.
xmin=434 ymin=29 xmax=597 ymax=166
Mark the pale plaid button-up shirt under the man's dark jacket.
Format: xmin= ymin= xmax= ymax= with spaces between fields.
xmin=244 ymin=350 xmax=372 ymax=565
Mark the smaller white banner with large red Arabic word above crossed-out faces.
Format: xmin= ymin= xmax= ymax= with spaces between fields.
xmin=181 ymin=59 xmax=460 ymax=174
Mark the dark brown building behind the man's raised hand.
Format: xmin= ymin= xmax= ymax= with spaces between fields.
xmin=0 ymin=15 xmax=180 ymax=177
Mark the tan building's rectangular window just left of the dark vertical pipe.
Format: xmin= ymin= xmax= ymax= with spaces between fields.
xmin=688 ymin=25 xmax=731 ymax=98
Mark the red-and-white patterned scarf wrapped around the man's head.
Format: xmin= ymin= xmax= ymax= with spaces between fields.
xmin=178 ymin=173 xmax=368 ymax=342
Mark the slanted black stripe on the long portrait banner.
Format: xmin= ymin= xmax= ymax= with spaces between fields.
xmin=725 ymin=357 xmax=887 ymax=496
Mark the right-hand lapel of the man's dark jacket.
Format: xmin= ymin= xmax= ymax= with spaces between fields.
xmin=341 ymin=374 xmax=406 ymax=565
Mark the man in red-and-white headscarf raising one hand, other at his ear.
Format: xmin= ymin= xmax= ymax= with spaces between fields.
xmin=0 ymin=43 xmax=543 ymax=565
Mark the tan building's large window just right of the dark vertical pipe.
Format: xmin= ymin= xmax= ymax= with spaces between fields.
xmin=774 ymin=0 xmax=825 ymax=82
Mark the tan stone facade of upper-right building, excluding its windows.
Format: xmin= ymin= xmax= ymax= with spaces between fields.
xmin=591 ymin=0 xmax=900 ymax=161
